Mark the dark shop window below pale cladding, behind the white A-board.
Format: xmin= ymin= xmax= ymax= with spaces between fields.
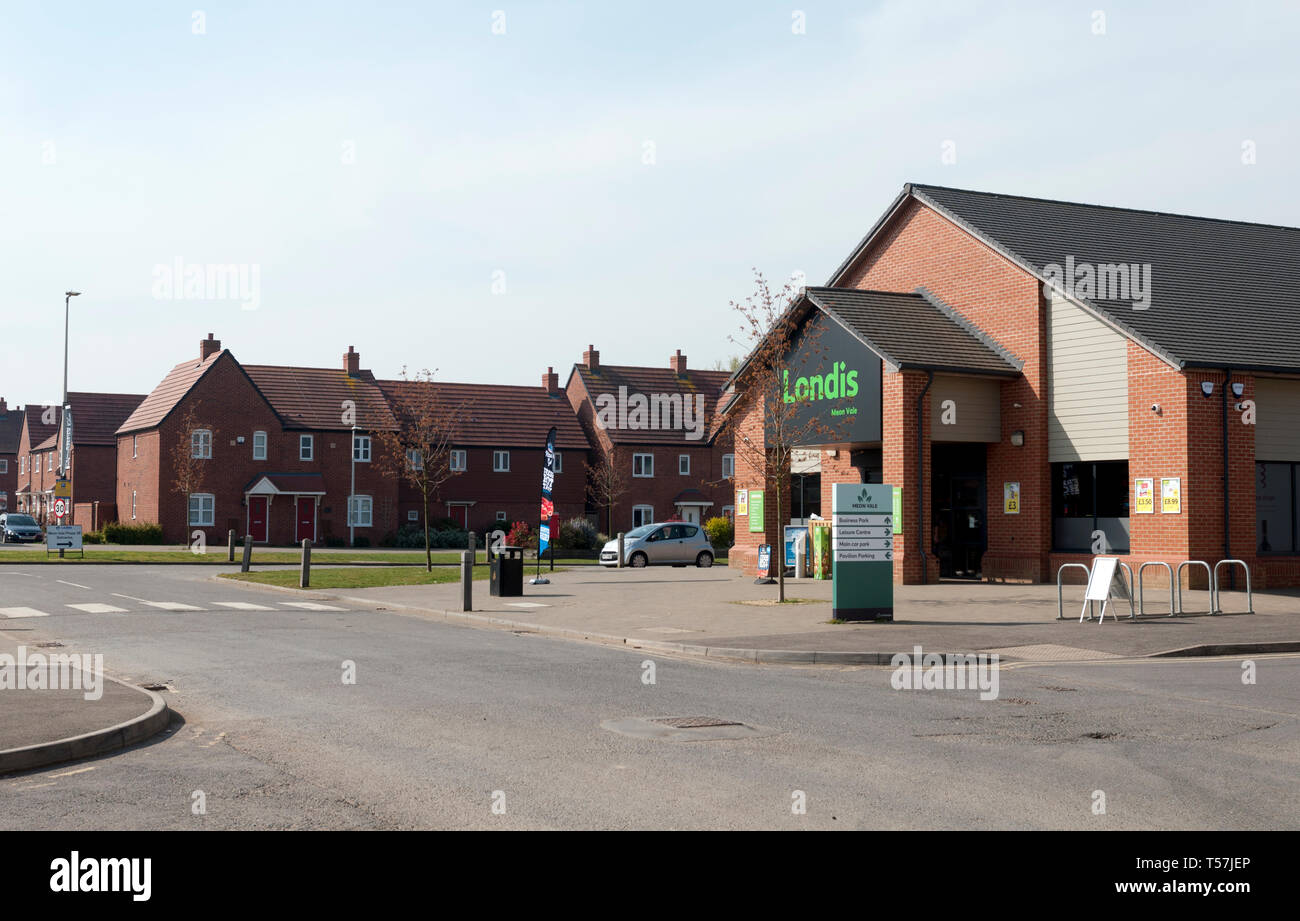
xmin=1052 ymin=461 xmax=1130 ymax=553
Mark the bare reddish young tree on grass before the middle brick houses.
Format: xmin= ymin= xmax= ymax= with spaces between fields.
xmin=373 ymin=368 xmax=463 ymax=572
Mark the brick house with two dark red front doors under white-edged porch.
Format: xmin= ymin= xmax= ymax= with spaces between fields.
xmin=116 ymin=333 xmax=398 ymax=545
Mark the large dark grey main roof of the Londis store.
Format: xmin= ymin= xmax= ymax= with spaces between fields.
xmin=829 ymin=185 xmax=1300 ymax=372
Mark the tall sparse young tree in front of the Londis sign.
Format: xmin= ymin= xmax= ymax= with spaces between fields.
xmin=723 ymin=269 xmax=842 ymax=602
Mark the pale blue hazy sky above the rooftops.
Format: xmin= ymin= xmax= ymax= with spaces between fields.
xmin=0 ymin=0 xmax=1300 ymax=403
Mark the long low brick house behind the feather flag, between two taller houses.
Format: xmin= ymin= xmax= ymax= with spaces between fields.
xmin=380 ymin=368 xmax=592 ymax=535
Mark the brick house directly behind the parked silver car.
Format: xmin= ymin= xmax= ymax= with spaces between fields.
xmin=564 ymin=346 xmax=735 ymax=533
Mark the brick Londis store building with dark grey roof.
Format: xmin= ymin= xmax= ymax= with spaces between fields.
xmin=727 ymin=185 xmax=1300 ymax=588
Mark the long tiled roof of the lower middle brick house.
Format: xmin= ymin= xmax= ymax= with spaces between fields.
xmin=378 ymin=381 xmax=592 ymax=451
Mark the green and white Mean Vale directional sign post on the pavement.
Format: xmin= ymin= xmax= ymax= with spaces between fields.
xmin=831 ymin=483 xmax=894 ymax=621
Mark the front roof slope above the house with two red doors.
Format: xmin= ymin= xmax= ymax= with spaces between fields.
xmin=243 ymin=364 xmax=397 ymax=432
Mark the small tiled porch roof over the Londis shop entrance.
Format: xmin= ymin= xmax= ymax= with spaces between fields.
xmin=803 ymin=287 xmax=1022 ymax=377
